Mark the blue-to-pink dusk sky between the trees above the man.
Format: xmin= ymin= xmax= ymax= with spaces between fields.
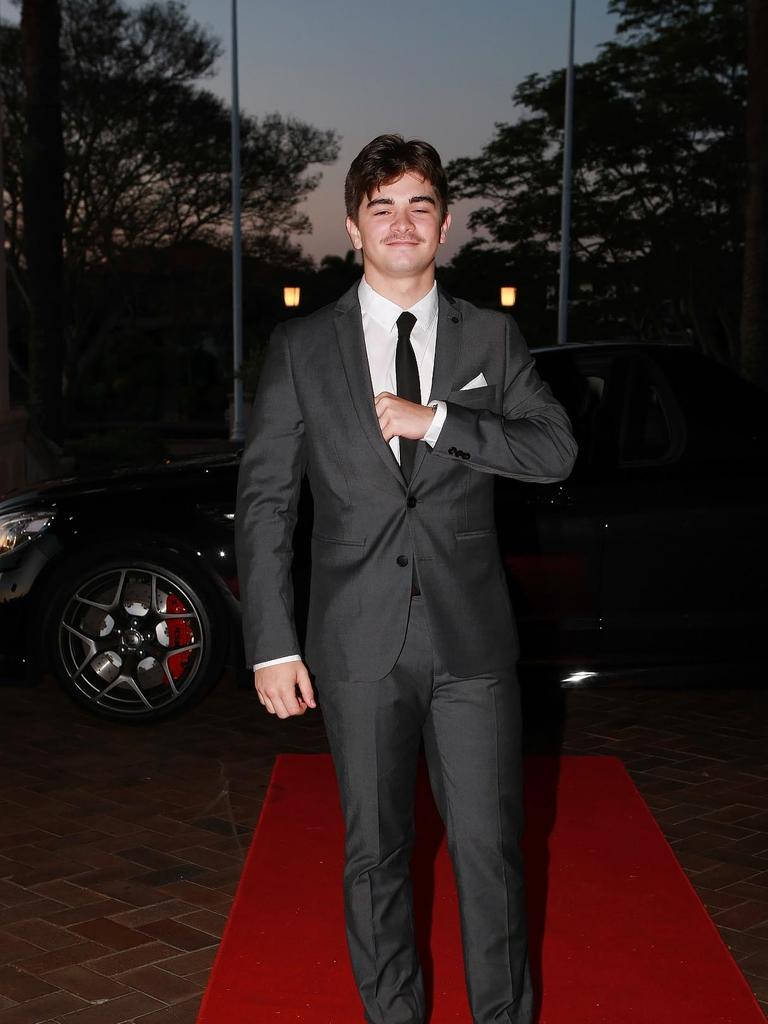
xmin=0 ymin=0 xmax=615 ymax=261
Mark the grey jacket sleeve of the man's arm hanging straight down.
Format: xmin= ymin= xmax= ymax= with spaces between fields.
xmin=234 ymin=325 xmax=306 ymax=665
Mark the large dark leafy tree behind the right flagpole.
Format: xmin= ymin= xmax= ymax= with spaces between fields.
xmin=449 ymin=0 xmax=745 ymax=361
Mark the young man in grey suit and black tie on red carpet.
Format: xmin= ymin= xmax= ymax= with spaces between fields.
xmin=237 ymin=135 xmax=575 ymax=1024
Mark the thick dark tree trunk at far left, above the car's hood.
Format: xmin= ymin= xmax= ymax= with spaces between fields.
xmin=22 ymin=0 xmax=63 ymax=439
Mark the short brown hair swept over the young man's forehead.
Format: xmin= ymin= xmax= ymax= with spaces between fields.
xmin=344 ymin=135 xmax=447 ymax=224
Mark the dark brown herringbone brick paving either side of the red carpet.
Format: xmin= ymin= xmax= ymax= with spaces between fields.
xmin=0 ymin=677 xmax=768 ymax=1024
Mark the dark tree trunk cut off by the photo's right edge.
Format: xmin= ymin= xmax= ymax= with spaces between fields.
xmin=740 ymin=0 xmax=768 ymax=389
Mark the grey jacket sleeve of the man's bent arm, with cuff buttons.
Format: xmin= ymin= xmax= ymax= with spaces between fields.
xmin=432 ymin=317 xmax=577 ymax=483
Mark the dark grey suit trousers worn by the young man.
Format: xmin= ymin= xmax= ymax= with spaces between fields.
xmin=316 ymin=596 xmax=532 ymax=1024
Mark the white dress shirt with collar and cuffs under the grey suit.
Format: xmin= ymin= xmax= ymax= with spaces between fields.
xmin=254 ymin=278 xmax=447 ymax=670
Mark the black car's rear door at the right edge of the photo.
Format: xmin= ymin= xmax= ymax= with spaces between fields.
xmin=600 ymin=348 xmax=768 ymax=664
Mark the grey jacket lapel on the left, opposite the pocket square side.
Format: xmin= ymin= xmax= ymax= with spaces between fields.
xmin=336 ymin=284 xmax=406 ymax=487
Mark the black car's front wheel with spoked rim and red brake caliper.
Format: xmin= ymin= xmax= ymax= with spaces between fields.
xmin=46 ymin=553 xmax=226 ymax=722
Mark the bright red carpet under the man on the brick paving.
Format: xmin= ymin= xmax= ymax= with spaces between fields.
xmin=198 ymin=755 xmax=765 ymax=1024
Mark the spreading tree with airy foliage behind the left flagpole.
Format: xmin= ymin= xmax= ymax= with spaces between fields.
xmin=0 ymin=0 xmax=338 ymax=419
